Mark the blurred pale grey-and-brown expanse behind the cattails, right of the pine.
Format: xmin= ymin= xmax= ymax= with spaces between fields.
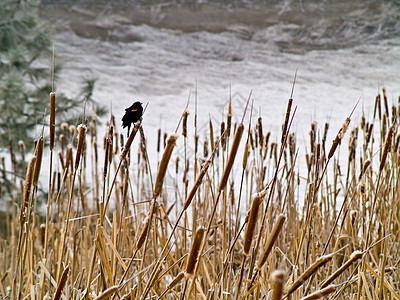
xmin=39 ymin=1 xmax=400 ymax=202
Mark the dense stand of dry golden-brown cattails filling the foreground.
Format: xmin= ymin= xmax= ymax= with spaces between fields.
xmin=0 ymin=86 xmax=400 ymax=300
